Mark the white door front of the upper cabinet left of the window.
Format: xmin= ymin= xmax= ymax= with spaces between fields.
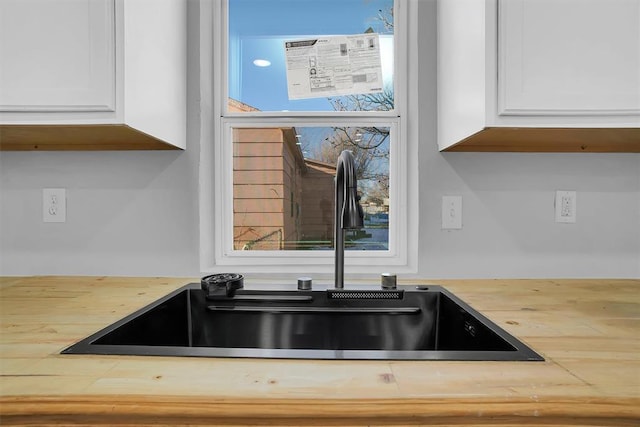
xmin=0 ymin=0 xmax=116 ymax=111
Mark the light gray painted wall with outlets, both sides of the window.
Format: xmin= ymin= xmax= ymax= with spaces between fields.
xmin=0 ymin=0 xmax=640 ymax=278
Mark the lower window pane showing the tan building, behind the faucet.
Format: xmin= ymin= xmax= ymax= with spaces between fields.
xmin=232 ymin=126 xmax=391 ymax=250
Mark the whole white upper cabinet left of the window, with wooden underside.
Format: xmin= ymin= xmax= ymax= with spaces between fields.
xmin=0 ymin=0 xmax=186 ymax=150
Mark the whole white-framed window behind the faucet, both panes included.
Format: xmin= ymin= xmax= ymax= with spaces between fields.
xmin=203 ymin=0 xmax=413 ymax=271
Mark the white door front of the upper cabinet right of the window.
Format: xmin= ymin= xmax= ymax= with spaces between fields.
xmin=498 ymin=0 xmax=640 ymax=116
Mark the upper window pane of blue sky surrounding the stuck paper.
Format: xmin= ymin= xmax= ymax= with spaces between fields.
xmin=227 ymin=0 xmax=394 ymax=112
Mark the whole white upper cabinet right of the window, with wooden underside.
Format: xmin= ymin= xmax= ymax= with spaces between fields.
xmin=438 ymin=0 xmax=640 ymax=151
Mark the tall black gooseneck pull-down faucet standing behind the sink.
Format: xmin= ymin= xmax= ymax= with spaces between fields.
xmin=334 ymin=150 xmax=364 ymax=289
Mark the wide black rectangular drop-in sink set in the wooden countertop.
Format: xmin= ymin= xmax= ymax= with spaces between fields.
xmin=62 ymin=283 xmax=544 ymax=360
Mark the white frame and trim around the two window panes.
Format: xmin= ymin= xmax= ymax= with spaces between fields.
xmin=199 ymin=0 xmax=418 ymax=275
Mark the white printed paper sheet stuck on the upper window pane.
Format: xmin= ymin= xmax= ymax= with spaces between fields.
xmin=284 ymin=33 xmax=382 ymax=99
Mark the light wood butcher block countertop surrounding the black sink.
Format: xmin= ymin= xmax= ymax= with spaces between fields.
xmin=0 ymin=277 xmax=640 ymax=426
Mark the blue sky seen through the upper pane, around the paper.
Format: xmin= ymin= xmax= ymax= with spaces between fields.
xmin=229 ymin=0 xmax=392 ymax=111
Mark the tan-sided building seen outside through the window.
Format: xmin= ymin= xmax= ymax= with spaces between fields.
xmin=229 ymin=100 xmax=335 ymax=250
